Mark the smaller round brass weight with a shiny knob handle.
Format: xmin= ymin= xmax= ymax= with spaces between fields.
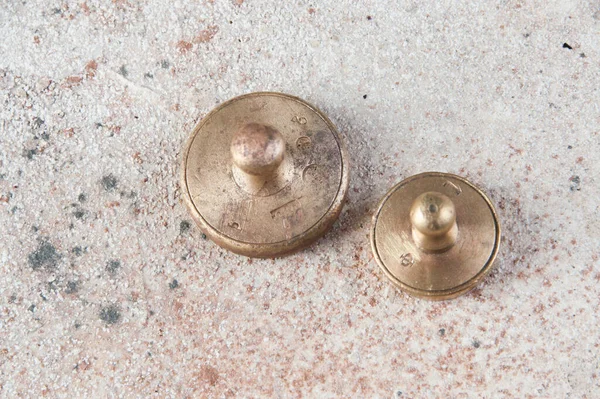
xmin=371 ymin=172 xmax=500 ymax=300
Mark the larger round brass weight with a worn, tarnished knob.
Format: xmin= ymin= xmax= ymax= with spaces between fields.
xmin=182 ymin=93 xmax=349 ymax=258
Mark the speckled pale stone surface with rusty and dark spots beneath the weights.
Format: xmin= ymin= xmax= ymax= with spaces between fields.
xmin=0 ymin=0 xmax=600 ymax=399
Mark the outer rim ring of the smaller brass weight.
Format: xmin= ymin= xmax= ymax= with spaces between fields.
xmin=370 ymin=172 xmax=502 ymax=301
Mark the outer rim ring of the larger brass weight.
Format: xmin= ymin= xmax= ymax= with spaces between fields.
xmin=180 ymin=91 xmax=350 ymax=258
